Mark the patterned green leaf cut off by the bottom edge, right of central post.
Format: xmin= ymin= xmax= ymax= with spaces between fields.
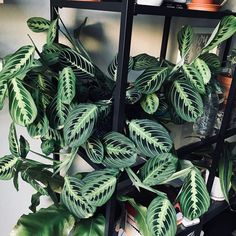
xmin=147 ymin=196 xmax=177 ymax=236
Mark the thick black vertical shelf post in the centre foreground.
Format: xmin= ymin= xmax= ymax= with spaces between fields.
xmin=105 ymin=0 xmax=135 ymax=236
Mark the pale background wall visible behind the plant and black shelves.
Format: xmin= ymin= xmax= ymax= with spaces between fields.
xmin=0 ymin=0 xmax=236 ymax=236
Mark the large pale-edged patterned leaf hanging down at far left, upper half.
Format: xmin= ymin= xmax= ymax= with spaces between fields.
xmin=8 ymin=78 xmax=37 ymax=126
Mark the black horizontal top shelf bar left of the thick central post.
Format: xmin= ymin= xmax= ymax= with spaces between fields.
xmin=51 ymin=0 xmax=122 ymax=12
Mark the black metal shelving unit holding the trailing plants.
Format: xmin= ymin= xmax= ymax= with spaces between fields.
xmin=51 ymin=0 xmax=236 ymax=236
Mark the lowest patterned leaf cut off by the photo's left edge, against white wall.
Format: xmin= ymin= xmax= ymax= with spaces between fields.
xmin=0 ymin=155 xmax=18 ymax=180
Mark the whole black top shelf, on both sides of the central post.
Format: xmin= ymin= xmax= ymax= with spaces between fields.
xmin=51 ymin=0 xmax=236 ymax=19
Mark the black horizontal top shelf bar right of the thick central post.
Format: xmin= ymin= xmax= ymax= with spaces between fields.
xmin=135 ymin=5 xmax=236 ymax=19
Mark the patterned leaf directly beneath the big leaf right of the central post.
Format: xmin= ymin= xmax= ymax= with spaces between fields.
xmin=140 ymin=153 xmax=178 ymax=186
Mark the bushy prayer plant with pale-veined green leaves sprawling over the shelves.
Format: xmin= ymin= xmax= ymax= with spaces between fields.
xmin=0 ymin=13 xmax=236 ymax=236
